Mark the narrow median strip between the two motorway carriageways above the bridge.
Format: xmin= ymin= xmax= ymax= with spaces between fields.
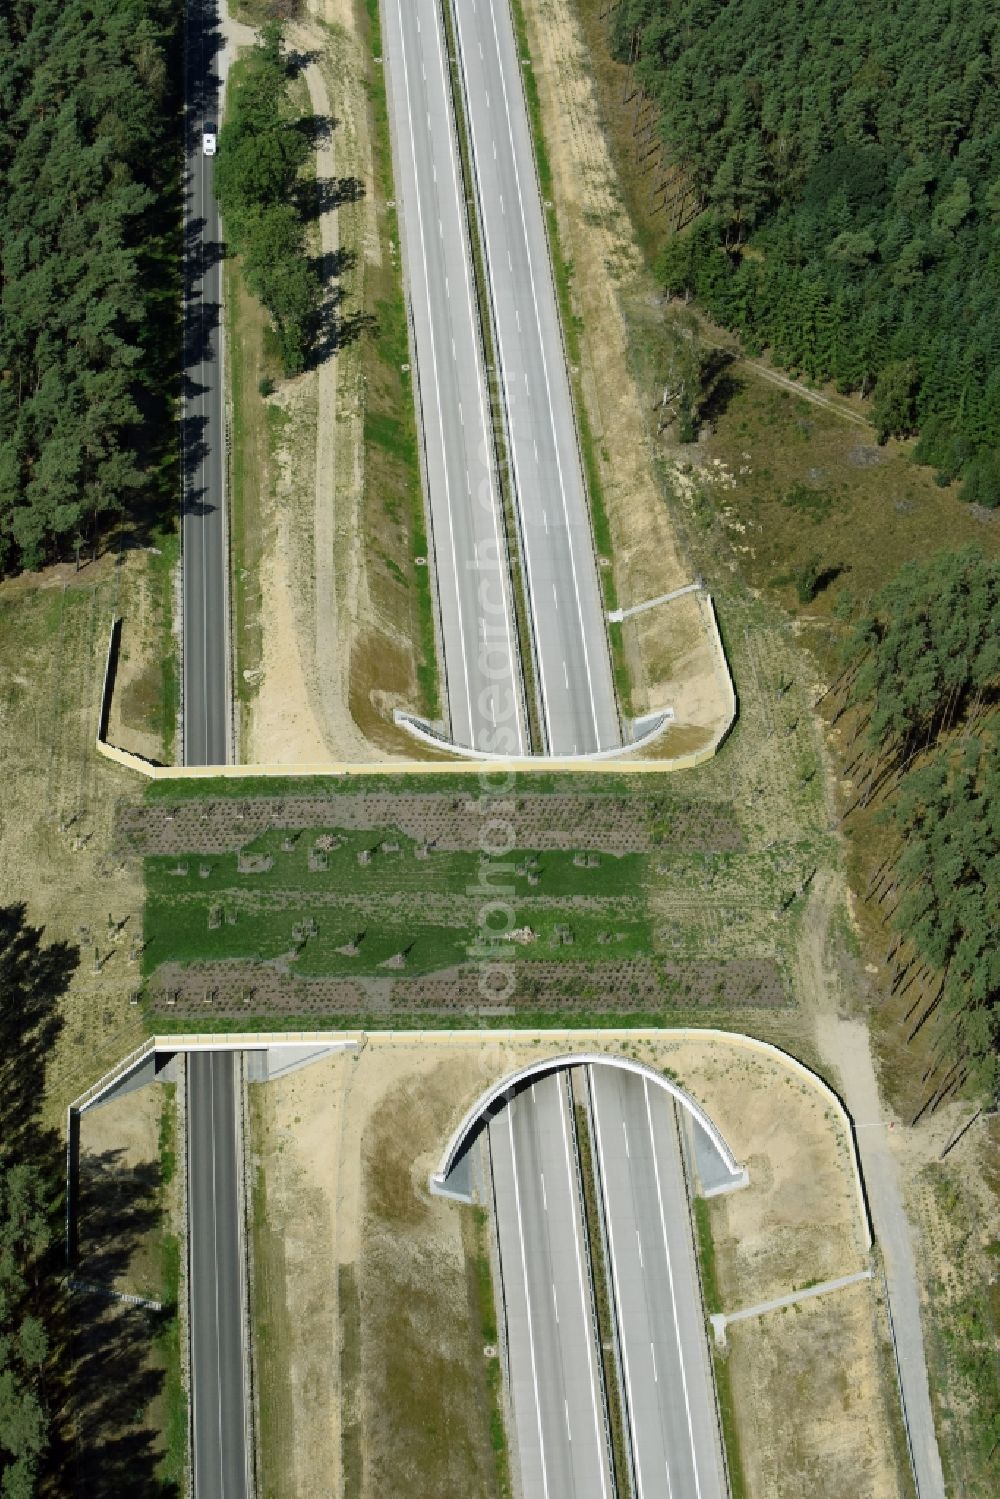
xmin=441 ymin=3 xmax=544 ymax=750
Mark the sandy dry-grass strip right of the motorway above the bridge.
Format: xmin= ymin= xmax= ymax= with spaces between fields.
xmin=523 ymin=0 xmax=724 ymax=731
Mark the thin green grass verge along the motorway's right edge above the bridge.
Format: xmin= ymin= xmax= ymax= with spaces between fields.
xmin=510 ymin=0 xmax=633 ymax=717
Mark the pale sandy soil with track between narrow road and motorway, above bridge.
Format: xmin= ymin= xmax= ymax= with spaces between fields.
xmin=228 ymin=0 xmax=414 ymax=764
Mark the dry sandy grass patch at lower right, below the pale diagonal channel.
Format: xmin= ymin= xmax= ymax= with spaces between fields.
xmin=726 ymin=1283 xmax=900 ymax=1499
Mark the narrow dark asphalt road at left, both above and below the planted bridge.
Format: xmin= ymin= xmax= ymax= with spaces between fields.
xmin=181 ymin=0 xmax=245 ymax=1499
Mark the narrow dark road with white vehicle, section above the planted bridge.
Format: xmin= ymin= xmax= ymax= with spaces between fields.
xmin=181 ymin=0 xmax=229 ymax=764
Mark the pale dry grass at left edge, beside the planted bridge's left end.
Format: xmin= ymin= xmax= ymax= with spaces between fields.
xmin=0 ymin=552 xmax=154 ymax=1127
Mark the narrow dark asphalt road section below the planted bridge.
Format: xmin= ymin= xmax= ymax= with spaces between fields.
xmin=187 ymin=1051 xmax=252 ymax=1499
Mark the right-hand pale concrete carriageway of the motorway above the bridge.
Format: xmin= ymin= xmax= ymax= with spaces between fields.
xmin=452 ymin=0 xmax=621 ymax=755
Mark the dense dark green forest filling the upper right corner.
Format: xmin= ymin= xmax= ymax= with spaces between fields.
xmin=610 ymin=0 xmax=1000 ymax=494
